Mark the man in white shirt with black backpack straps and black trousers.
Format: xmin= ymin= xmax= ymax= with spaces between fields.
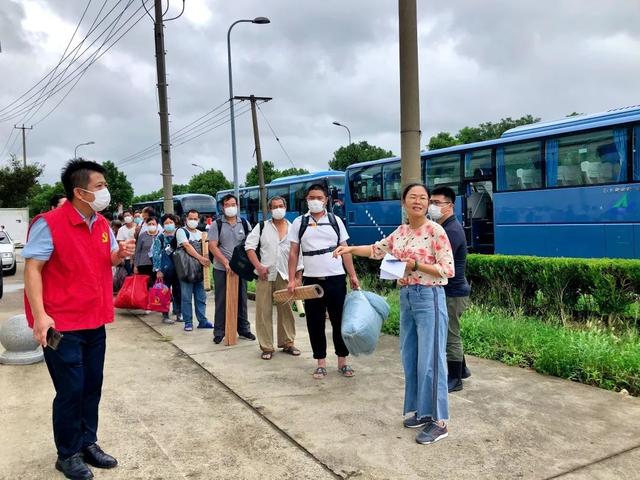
xmin=287 ymin=184 xmax=360 ymax=380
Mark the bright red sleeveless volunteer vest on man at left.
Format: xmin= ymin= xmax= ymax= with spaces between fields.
xmin=24 ymin=201 xmax=114 ymax=332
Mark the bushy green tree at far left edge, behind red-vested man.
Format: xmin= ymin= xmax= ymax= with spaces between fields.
xmin=0 ymin=155 xmax=43 ymax=208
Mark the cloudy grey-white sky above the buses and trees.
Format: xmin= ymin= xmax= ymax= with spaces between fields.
xmin=0 ymin=0 xmax=640 ymax=194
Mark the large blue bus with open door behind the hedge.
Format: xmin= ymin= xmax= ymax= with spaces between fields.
xmin=345 ymin=106 xmax=640 ymax=258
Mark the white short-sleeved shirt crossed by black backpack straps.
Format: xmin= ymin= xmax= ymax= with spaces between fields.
xmin=289 ymin=210 xmax=349 ymax=278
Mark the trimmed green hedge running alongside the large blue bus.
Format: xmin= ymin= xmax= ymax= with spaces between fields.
xmin=467 ymin=254 xmax=640 ymax=326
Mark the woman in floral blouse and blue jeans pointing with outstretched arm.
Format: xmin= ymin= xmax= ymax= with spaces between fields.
xmin=334 ymin=183 xmax=454 ymax=444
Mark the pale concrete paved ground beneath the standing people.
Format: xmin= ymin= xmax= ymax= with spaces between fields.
xmin=0 ymin=260 xmax=640 ymax=480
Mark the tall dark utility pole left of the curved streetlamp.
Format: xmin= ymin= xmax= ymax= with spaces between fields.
xmin=154 ymin=0 xmax=173 ymax=213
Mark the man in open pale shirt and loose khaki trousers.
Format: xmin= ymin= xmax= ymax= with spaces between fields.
xmin=245 ymin=197 xmax=302 ymax=360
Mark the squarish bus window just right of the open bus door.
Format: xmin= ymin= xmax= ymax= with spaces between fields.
xmin=496 ymin=142 xmax=542 ymax=191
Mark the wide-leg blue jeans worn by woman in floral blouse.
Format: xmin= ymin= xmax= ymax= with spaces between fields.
xmin=400 ymin=285 xmax=449 ymax=420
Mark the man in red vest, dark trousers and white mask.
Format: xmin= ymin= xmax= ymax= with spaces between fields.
xmin=23 ymin=159 xmax=135 ymax=480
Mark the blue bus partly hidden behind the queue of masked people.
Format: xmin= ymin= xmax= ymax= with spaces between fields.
xmin=216 ymin=170 xmax=345 ymax=225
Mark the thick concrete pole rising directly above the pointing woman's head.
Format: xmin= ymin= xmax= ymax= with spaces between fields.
xmin=398 ymin=0 xmax=422 ymax=188
